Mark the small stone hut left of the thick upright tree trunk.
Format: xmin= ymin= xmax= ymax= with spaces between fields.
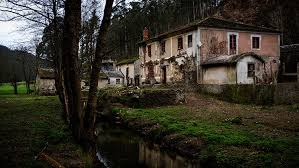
xmin=35 ymin=68 xmax=56 ymax=95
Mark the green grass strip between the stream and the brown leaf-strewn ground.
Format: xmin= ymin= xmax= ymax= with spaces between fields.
xmin=114 ymin=106 xmax=299 ymax=167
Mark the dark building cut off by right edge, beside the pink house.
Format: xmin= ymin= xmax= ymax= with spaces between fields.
xmin=279 ymin=44 xmax=299 ymax=82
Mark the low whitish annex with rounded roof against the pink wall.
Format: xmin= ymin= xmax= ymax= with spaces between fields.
xmin=201 ymin=52 xmax=265 ymax=84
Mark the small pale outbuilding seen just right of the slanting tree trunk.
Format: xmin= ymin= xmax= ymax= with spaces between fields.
xmin=98 ymin=71 xmax=124 ymax=88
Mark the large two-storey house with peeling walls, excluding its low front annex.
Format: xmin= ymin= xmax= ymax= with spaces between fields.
xmin=139 ymin=18 xmax=280 ymax=83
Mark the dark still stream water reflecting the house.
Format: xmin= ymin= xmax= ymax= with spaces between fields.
xmin=97 ymin=123 xmax=200 ymax=168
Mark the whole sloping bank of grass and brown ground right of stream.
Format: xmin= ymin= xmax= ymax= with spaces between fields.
xmin=114 ymin=95 xmax=299 ymax=167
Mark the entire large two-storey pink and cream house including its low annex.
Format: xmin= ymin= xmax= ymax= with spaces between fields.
xmin=139 ymin=17 xmax=280 ymax=84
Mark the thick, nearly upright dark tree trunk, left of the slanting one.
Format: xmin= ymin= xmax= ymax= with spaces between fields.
xmin=62 ymin=0 xmax=84 ymax=143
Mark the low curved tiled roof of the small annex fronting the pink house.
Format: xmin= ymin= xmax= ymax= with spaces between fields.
xmin=201 ymin=52 xmax=265 ymax=65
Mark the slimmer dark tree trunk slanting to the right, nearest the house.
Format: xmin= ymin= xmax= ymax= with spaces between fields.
xmin=84 ymin=0 xmax=113 ymax=144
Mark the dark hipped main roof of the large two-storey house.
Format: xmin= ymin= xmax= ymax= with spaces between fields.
xmin=139 ymin=17 xmax=281 ymax=44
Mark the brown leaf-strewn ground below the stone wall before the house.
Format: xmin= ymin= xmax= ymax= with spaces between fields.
xmin=186 ymin=94 xmax=299 ymax=136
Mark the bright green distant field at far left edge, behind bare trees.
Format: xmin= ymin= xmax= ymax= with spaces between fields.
xmin=0 ymin=82 xmax=34 ymax=95
